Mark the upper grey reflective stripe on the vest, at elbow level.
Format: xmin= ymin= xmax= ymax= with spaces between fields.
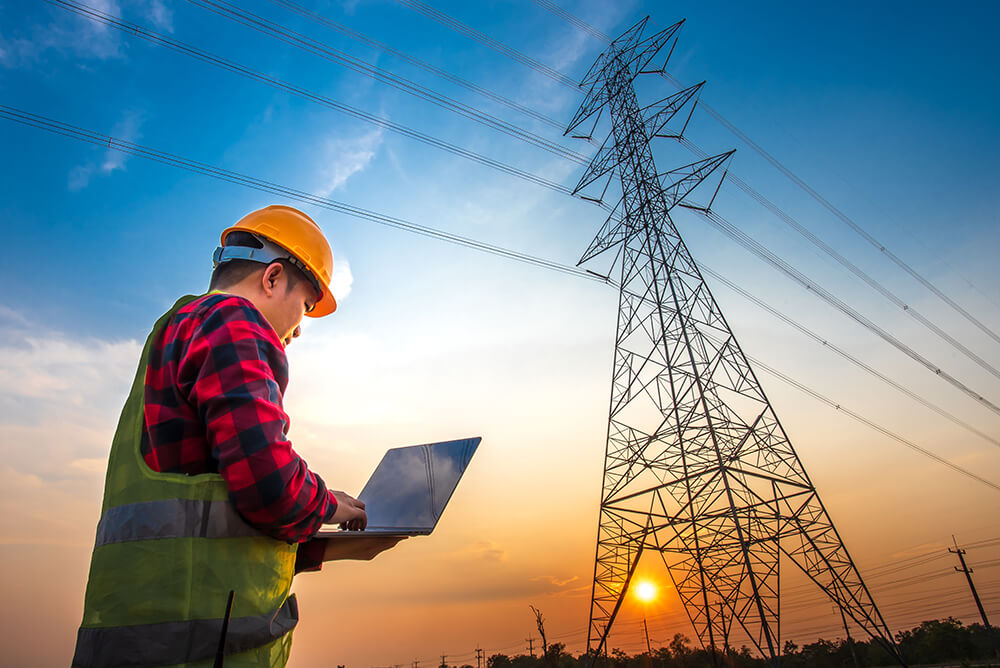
xmin=94 ymin=499 xmax=263 ymax=547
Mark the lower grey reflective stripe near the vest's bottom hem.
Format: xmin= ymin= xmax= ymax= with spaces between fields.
xmin=73 ymin=595 xmax=299 ymax=666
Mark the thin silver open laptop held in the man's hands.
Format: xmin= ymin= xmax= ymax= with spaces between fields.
xmin=316 ymin=437 xmax=482 ymax=538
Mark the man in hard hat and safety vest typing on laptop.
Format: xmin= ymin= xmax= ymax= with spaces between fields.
xmin=73 ymin=206 xmax=399 ymax=668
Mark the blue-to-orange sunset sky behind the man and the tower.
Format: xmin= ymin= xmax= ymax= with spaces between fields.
xmin=0 ymin=0 xmax=1000 ymax=668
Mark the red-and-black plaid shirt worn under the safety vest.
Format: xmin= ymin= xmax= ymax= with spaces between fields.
xmin=141 ymin=293 xmax=337 ymax=572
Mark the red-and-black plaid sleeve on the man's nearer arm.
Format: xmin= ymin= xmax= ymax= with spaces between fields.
xmin=179 ymin=297 xmax=337 ymax=543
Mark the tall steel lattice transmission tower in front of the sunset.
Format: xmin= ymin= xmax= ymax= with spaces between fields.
xmin=566 ymin=19 xmax=902 ymax=665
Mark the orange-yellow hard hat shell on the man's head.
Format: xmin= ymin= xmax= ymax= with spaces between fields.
xmin=220 ymin=204 xmax=337 ymax=318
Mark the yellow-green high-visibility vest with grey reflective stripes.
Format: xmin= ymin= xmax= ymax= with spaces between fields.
xmin=73 ymin=295 xmax=298 ymax=668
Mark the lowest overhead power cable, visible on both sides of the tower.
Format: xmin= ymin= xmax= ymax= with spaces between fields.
xmin=0 ymin=104 xmax=1000 ymax=491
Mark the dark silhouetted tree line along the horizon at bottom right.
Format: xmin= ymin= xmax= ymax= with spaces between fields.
xmin=439 ymin=611 xmax=1000 ymax=668
